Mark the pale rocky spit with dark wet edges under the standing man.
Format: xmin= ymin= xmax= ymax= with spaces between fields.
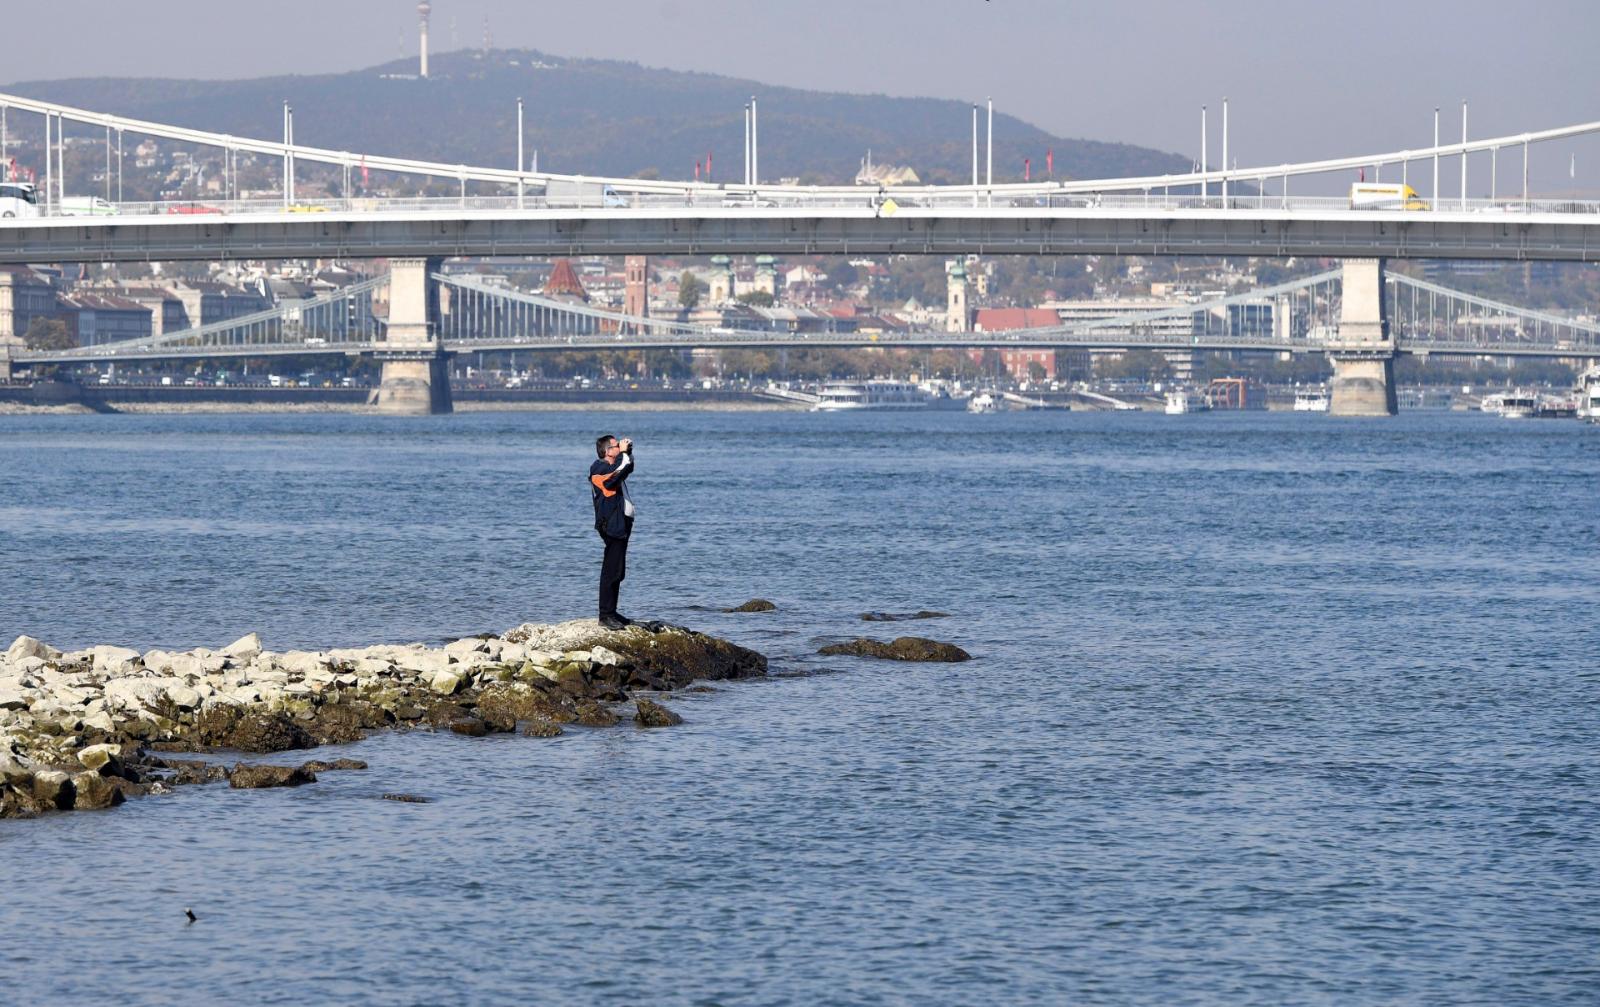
xmin=0 ymin=620 xmax=766 ymax=818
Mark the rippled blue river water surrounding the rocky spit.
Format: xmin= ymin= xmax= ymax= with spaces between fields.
xmin=0 ymin=406 xmax=1600 ymax=1005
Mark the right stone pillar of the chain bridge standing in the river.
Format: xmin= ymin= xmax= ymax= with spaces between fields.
xmin=1328 ymin=259 xmax=1398 ymax=416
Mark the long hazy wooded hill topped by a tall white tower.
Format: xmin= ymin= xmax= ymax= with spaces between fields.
xmin=0 ymin=50 xmax=1189 ymax=183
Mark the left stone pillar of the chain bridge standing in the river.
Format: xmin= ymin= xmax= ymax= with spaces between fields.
xmin=373 ymin=259 xmax=453 ymax=415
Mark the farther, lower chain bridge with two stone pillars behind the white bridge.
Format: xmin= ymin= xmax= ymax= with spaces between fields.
xmin=11 ymin=261 xmax=1600 ymax=411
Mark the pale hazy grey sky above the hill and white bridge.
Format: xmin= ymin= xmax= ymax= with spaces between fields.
xmin=9 ymin=0 xmax=1600 ymax=195
